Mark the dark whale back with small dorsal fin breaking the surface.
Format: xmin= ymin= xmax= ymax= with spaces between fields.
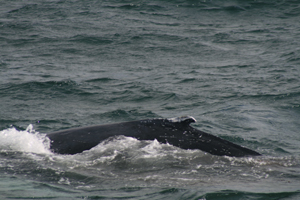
xmin=47 ymin=116 xmax=261 ymax=157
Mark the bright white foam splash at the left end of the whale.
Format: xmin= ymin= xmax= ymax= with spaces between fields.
xmin=0 ymin=124 xmax=51 ymax=154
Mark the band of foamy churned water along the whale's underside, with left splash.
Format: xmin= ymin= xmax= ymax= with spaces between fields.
xmin=0 ymin=124 xmax=300 ymax=173
